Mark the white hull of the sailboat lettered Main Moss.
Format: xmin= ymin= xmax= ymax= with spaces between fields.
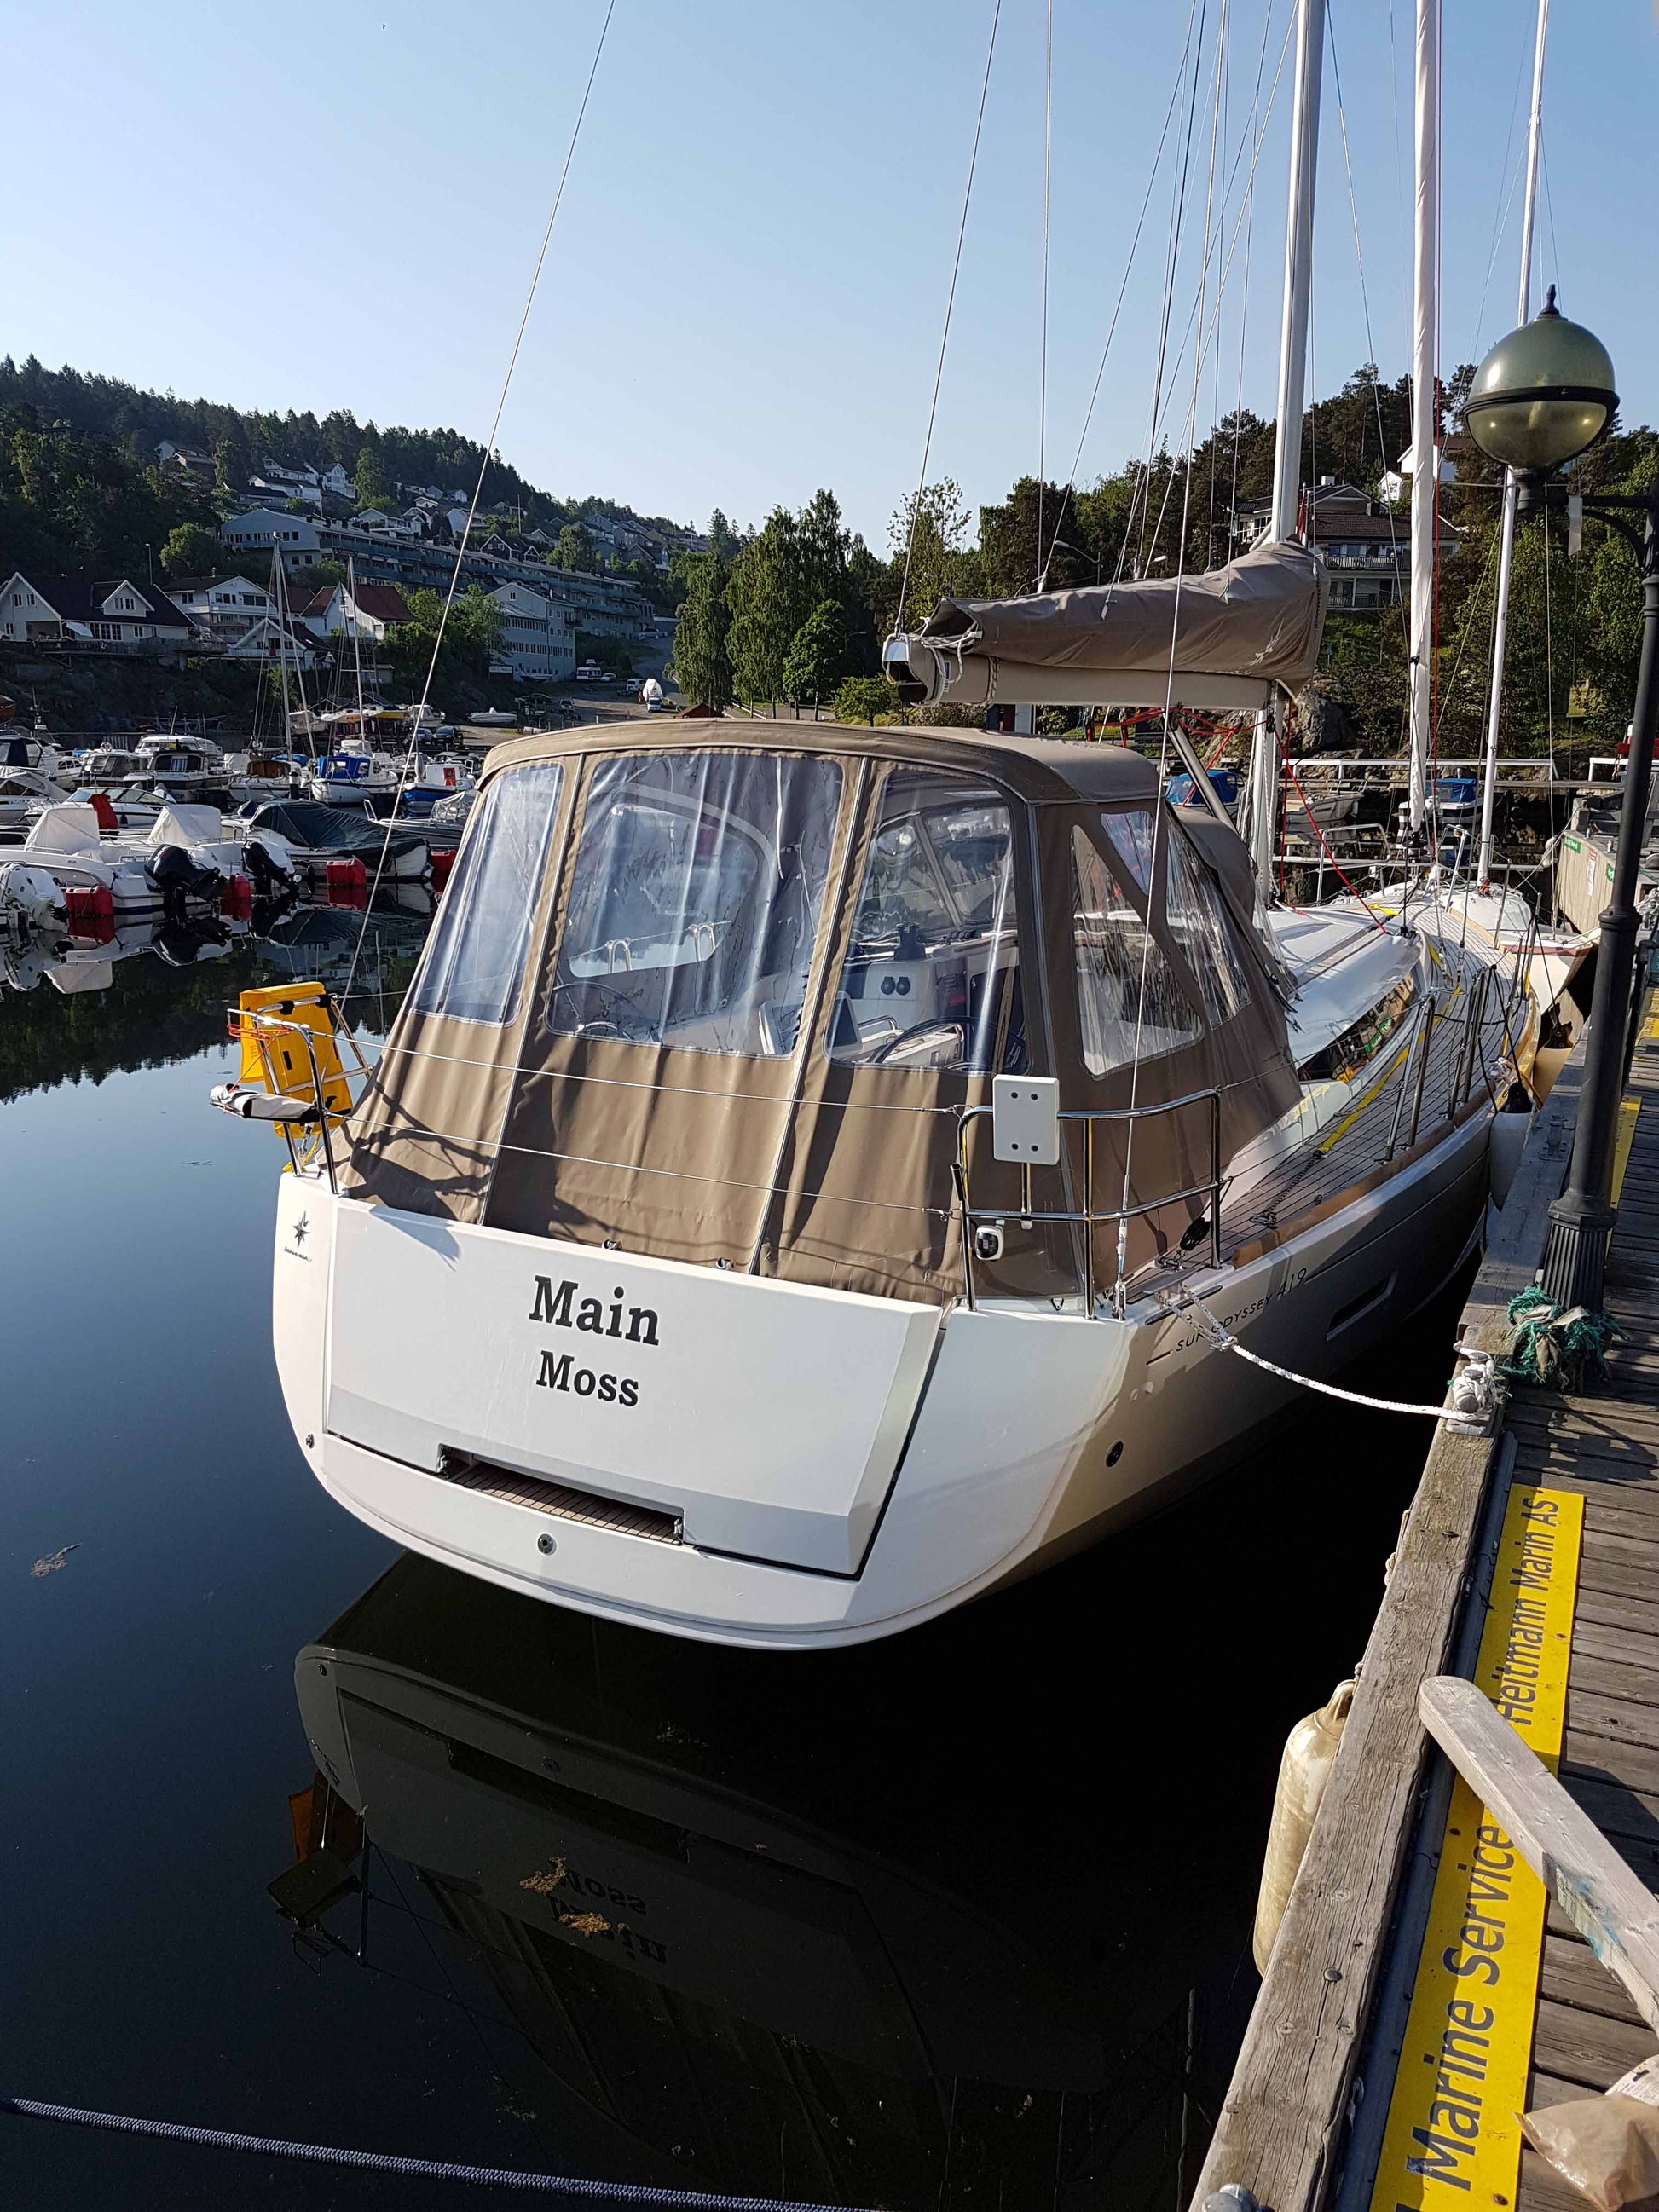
xmin=275 ymin=1106 xmax=1491 ymax=1650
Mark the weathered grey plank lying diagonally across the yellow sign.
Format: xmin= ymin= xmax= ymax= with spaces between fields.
xmin=1418 ymin=1674 xmax=1659 ymax=2035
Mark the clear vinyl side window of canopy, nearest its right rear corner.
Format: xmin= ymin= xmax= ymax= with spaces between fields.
xmin=1071 ymin=810 xmax=1201 ymax=1075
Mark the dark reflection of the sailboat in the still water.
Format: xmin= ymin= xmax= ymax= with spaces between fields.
xmin=283 ymin=1555 xmax=1254 ymax=2212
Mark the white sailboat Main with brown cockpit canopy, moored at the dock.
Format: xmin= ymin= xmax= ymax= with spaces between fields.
xmin=219 ymin=0 xmax=1535 ymax=1650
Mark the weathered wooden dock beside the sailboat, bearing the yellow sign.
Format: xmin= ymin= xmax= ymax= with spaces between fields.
xmin=1194 ymin=996 xmax=1659 ymax=2212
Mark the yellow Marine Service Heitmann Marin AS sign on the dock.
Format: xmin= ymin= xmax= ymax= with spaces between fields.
xmin=1372 ymin=1484 xmax=1584 ymax=2212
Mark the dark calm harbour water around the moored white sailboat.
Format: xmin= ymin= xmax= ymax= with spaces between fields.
xmin=0 ymin=929 xmax=1455 ymax=2212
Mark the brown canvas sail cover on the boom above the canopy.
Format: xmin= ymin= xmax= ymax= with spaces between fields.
xmin=922 ymin=544 xmax=1329 ymax=695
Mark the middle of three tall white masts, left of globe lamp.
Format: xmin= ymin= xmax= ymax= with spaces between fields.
xmin=1411 ymin=0 xmax=1440 ymax=834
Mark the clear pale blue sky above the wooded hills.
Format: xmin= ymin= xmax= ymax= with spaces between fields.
xmin=0 ymin=0 xmax=1659 ymax=546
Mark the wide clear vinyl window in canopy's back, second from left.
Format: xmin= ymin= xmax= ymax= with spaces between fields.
xmin=546 ymin=752 xmax=841 ymax=1060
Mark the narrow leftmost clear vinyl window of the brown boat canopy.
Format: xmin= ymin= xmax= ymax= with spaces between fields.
xmin=412 ymin=761 xmax=564 ymax=1022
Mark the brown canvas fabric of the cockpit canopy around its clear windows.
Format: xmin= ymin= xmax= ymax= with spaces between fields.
xmin=344 ymin=721 xmax=1301 ymax=1301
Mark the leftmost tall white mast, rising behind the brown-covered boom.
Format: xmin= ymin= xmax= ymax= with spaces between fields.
xmin=1247 ymin=0 xmax=1325 ymax=885
